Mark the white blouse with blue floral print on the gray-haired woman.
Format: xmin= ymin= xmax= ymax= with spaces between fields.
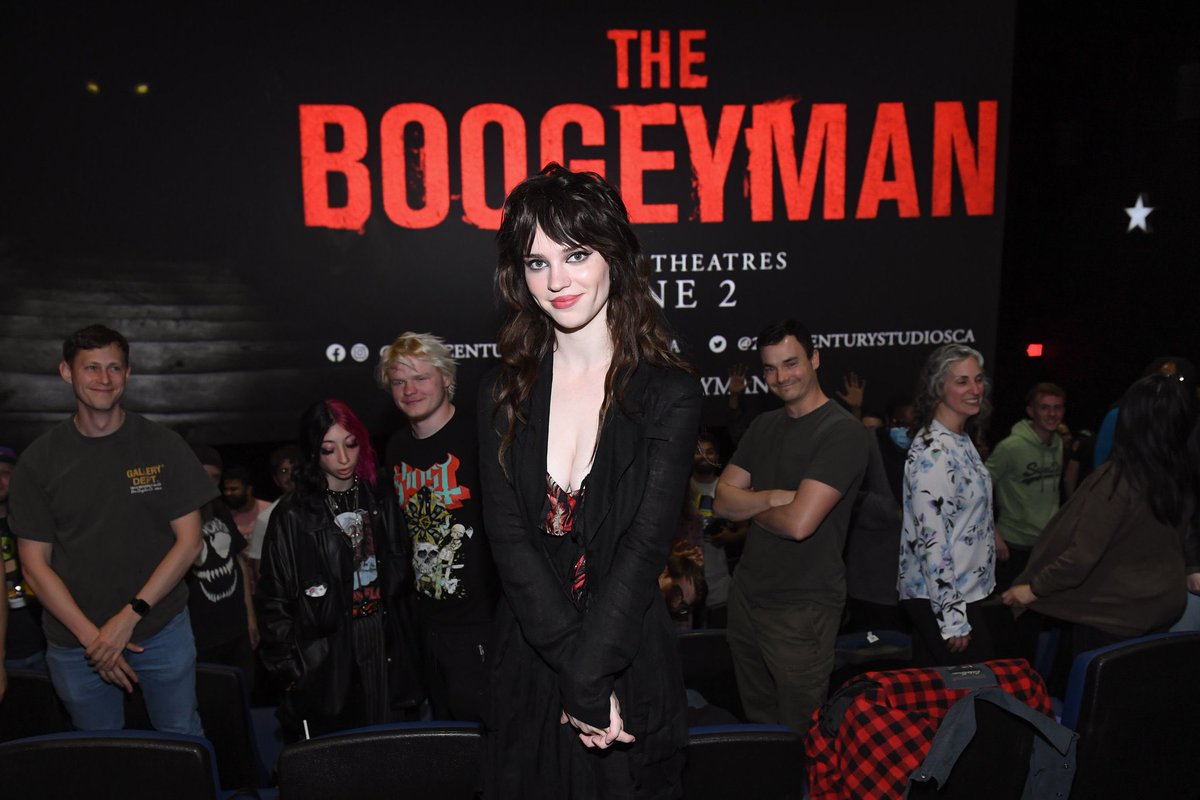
xmin=896 ymin=420 xmax=996 ymax=639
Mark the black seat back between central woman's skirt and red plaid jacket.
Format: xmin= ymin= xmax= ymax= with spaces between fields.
xmin=683 ymin=724 xmax=805 ymax=800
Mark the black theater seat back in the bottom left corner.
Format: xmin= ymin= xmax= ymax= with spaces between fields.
xmin=0 ymin=730 xmax=224 ymax=800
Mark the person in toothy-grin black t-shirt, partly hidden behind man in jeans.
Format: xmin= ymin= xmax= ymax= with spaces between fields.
xmin=187 ymin=444 xmax=258 ymax=692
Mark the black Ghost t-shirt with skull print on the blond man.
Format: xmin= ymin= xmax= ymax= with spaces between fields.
xmin=386 ymin=411 xmax=498 ymax=624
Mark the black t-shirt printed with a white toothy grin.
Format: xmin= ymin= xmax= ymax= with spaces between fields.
xmin=187 ymin=501 xmax=246 ymax=650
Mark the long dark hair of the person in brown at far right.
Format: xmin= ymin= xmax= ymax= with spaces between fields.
xmin=1112 ymin=374 xmax=1198 ymax=525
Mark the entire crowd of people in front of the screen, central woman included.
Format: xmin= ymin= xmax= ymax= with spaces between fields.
xmin=0 ymin=164 xmax=1200 ymax=798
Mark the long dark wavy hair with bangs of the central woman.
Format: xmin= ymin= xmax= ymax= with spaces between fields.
xmin=492 ymin=162 xmax=690 ymax=464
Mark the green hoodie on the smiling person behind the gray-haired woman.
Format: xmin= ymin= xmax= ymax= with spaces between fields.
xmin=988 ymin=420 xmax=1062 ymax=547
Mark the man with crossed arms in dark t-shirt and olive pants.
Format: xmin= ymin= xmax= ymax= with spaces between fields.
xmin=714 ymin=319 xmax=869 ymax=730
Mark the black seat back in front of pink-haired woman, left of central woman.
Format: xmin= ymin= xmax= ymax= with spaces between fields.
xmin=278 ymin=722 xmax=482 ymax=800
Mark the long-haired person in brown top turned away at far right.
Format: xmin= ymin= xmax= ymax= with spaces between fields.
xmin=1003 ymin=373 xmax=1198 ymax=681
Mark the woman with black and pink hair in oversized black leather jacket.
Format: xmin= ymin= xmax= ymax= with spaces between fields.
xmin=257 ymin=399 xmax=422 ymax=739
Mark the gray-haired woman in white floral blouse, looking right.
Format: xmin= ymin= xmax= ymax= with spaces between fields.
xmin=896 ymin=344 xmax=996 ymax=667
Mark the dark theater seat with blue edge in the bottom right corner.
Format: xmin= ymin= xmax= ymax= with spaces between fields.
xmin=1062 ymin=632 xmax=1200 ymax=800
